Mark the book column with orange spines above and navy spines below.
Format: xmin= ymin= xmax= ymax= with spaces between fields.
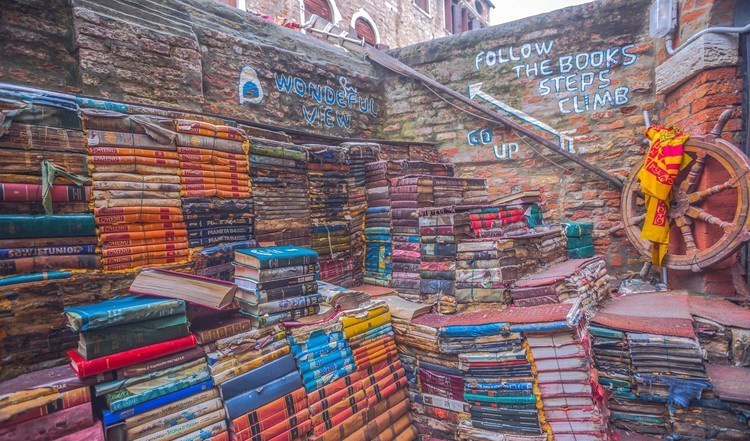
xmin=175 ymin=119 xmax=253 ymax=247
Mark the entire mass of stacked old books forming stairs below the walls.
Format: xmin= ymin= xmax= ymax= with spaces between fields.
xmin=0 ymin=89 xmax=750 ymax=441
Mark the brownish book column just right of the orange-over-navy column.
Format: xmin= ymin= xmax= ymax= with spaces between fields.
xmin=249 ymin=137 xmax=311 ymax=246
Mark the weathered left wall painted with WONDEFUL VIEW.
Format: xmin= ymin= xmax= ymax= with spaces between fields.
xmin=0 ymin=0 xmax=382 ymax=137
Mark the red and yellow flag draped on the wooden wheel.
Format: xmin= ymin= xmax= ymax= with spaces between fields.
xmin=638 ymin=126 xmax=691 ymax=266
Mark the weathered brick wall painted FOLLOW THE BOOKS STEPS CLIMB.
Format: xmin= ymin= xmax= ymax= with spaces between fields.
xmin=383 ymin=0 xmax=657 ymax=271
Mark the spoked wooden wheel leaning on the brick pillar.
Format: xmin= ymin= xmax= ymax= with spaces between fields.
xmin=621 ymin=126 xmax=750 ymax=272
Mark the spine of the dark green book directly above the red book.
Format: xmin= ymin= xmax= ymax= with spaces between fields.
xmin=78 ymin=323 xmax=190 ymax=360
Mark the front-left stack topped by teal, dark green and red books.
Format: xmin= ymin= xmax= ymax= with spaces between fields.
xmin=65 ymin=296 xmax=227 ymax=440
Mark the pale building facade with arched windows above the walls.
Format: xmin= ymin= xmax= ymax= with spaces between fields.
xmin=220 ymin=0 xmax=494 ymax=48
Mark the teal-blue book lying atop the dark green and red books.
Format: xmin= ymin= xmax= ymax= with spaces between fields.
xmin=65 ymin=296 xmax=185 ymax=332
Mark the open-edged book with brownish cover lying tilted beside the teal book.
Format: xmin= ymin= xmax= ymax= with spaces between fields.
xmin=130 ymin=268 xmax=237 ymax=309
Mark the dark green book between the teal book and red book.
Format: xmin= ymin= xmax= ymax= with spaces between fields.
xmin=78 ymin=314 xmax=190 ymax=360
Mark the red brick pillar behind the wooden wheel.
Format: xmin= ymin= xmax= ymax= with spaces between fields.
xmin=658 ymin=0 xmax=746 ymax=296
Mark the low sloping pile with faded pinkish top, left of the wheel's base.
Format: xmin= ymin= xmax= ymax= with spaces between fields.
xmin=510 ymin=256 xmax=609 ymax=309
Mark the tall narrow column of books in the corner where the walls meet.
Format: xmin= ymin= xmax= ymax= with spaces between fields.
xmin=341 ymin=142 xmax=380 ymax=286
